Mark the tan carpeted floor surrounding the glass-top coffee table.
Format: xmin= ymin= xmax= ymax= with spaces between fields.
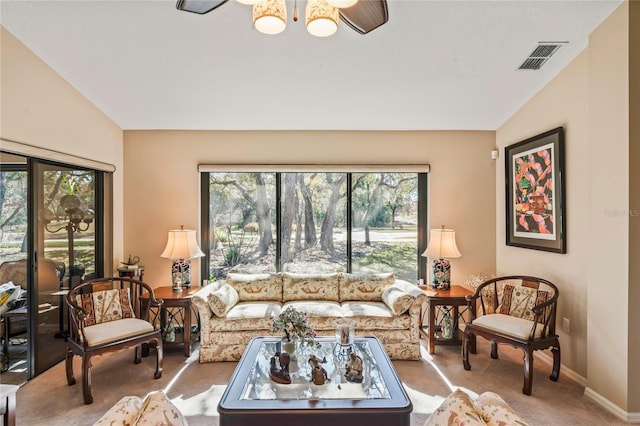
xmin=10 ymin=340 xmax=625 ymax=426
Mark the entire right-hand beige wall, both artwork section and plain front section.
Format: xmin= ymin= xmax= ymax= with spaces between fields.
xmin=496 ymin=3 xmax=640 ymax=416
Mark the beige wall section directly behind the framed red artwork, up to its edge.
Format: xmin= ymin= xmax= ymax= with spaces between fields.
xmin=496 ymin=52 xmax=590 ymax=376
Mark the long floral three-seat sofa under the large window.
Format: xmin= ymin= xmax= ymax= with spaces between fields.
xmin=192 ymin=272 xmax=426 ymax=362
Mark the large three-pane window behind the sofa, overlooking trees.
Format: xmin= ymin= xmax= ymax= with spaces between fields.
xmin=202 ymin=171 xmax=426 ymax=282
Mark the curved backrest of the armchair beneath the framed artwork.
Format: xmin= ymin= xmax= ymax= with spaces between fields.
xmin=467 ymin=275 xmax=560 ymax=335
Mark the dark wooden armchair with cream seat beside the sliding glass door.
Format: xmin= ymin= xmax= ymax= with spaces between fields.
xmin=65 ymin=277 xmax=163 ymax=404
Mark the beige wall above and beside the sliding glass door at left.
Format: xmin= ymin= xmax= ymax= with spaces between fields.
xmin=0 ymin=27 xmax=123 ymax=270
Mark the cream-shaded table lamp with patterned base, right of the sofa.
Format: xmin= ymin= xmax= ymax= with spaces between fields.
xmin=422 ymin=225 xmax=462 ymax=290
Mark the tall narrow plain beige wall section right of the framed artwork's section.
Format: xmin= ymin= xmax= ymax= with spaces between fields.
xmin=587 ymin=3 xmax=638 ymax=411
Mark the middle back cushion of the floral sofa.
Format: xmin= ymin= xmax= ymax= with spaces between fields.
xmin=282 ymin=272 xmax=340 ymax=302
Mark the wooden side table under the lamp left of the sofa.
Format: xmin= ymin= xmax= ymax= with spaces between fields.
xmin=140 ymin=286 xmax=200 ymax=357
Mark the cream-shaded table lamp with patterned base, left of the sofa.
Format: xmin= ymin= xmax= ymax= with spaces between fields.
xmin=160 ymin=225 xmax=204 ymax=291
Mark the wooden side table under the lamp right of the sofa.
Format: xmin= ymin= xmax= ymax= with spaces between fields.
xmin=420 ymin=285 xmax=473 ymax=354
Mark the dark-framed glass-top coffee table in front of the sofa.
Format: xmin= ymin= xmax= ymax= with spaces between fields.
xmin=218 ymin=337 xmax=413 ymax=426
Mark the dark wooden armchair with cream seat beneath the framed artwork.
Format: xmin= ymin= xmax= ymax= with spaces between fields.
xmin=462 ymin=275 xmax=560 ymax=395
